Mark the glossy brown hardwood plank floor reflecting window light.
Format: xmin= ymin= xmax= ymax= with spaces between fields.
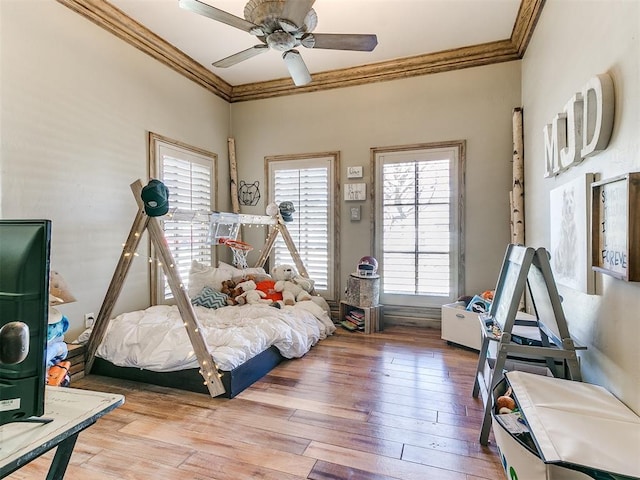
xmin=7 ymin=326 xmax=505 ymax=480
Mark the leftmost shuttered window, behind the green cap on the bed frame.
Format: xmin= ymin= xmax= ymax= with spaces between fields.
xmin=149 ymin=133 xmax=217 ymax=304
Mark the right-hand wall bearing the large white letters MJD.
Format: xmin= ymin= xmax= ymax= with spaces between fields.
xmin=522 ymin=0 xmax=640 ymax=413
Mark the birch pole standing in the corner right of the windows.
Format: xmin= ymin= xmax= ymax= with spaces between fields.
xmin=511 ymin=107 xmax=525 ymax=245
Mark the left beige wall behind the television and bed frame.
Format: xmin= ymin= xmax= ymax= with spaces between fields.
xmin=0 ymin=0 xmax=229 ymax=340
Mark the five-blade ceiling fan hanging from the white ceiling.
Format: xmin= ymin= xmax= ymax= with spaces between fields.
xmin=179 ymin=0 xmax=378 ymax=86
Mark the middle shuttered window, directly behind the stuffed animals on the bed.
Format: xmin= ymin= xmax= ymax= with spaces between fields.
xmin=265 ymin=153 xmax=339 ymax=300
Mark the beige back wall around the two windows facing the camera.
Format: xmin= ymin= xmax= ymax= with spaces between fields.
xmin=231 ymin=62 xmax=520 ymax=320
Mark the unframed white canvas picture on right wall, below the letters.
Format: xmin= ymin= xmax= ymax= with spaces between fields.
xmin=549 ymin=173 xmax=595 ymax=294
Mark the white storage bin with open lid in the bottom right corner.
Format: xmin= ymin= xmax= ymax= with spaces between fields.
xmin=492 ymin=372 xmax=640 ymax=480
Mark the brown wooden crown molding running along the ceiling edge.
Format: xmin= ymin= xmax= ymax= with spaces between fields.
xmin=57 ymin=0 xmax=545 ymax=103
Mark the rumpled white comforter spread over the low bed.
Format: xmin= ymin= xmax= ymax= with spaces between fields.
xmin=96 ymin=301 xmax=336 ymax=372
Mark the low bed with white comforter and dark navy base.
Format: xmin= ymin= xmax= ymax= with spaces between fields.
xmin=92 ymin=301 xmax=336 ymax=398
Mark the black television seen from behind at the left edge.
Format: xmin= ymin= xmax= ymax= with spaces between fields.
xmin=0 ymin=220 xmax=51 ymax=425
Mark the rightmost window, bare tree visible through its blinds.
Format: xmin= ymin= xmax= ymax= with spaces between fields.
xmin=373 ymin=142 xmax=464 ymax=307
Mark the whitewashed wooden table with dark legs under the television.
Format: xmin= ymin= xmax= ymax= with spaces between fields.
xmin=0 ymin=386 xmax=124 ymax=480
